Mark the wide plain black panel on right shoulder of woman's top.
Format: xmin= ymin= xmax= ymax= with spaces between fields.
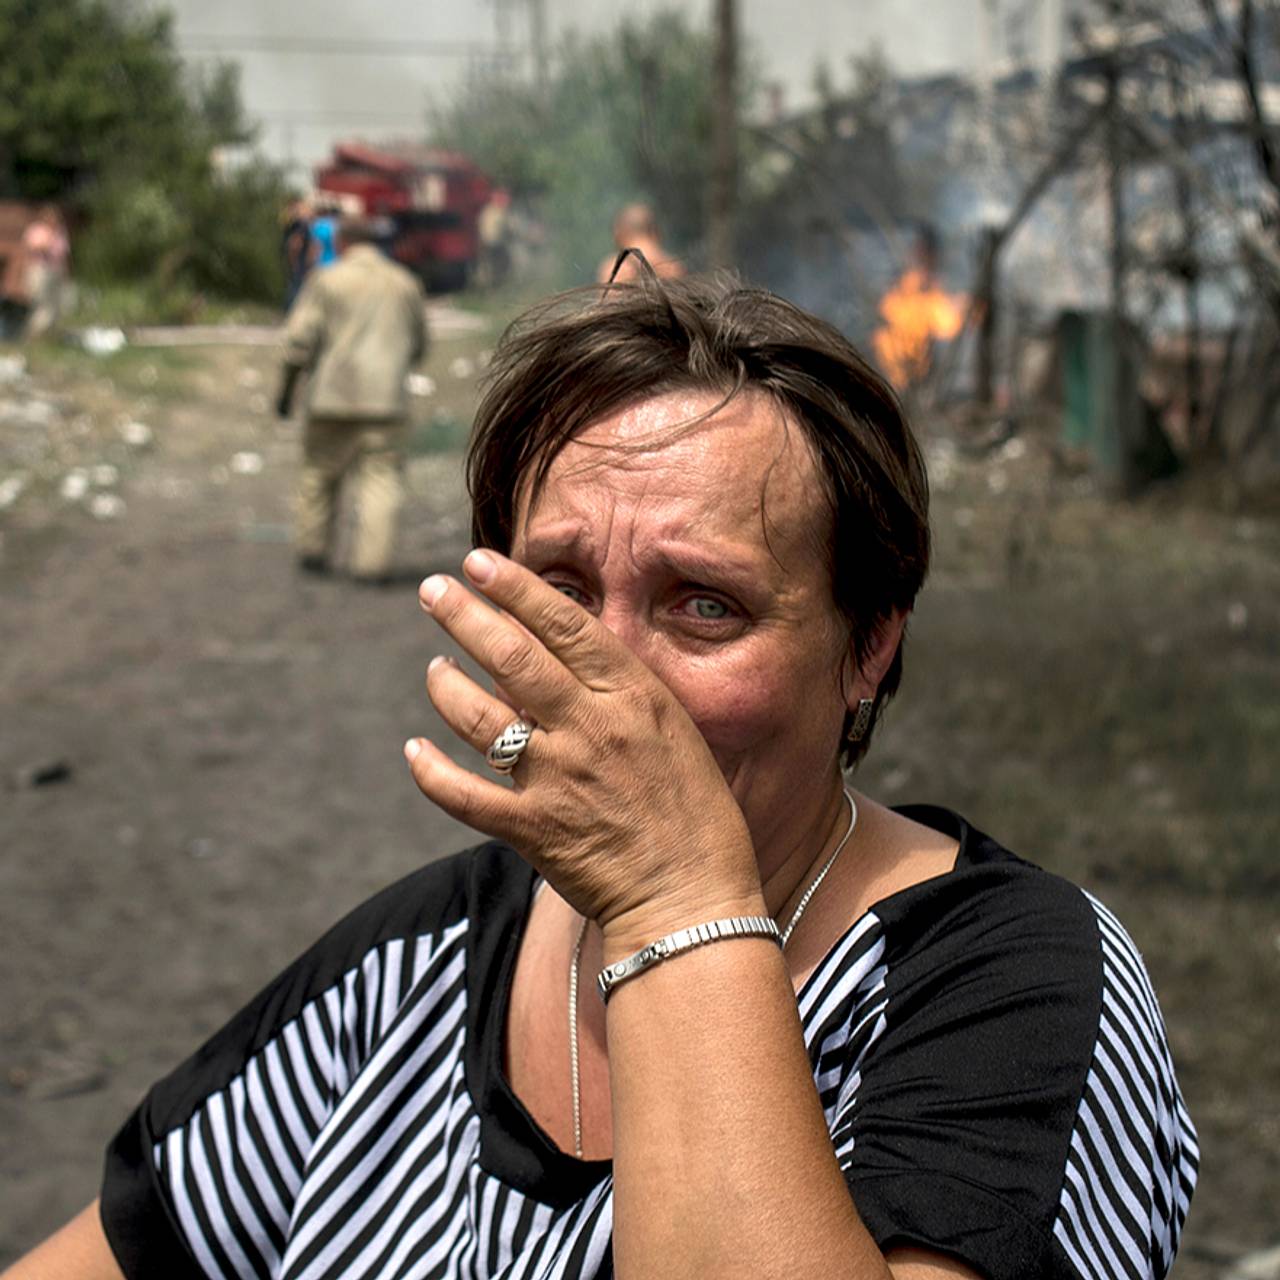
xmin=846 ymin=810 xmax=1102 ymax=1280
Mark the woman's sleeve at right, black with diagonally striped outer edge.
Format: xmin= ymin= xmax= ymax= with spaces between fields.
xmin=828 ymin=861 xmax=1197 ymax=1280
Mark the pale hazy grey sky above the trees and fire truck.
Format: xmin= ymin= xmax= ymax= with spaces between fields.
xmin=157 ymin=0 xmax=998 ymax=181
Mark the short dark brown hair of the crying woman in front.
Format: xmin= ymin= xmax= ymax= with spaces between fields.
xmin=467 ymin=264 xmax=929 ymax=768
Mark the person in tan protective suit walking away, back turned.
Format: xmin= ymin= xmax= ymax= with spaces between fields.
xmin=276 ymin=220 xmax=426 ymax=582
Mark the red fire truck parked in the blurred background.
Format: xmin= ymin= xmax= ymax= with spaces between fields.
xmin=316 ymin=142 xmax=493 ymax=292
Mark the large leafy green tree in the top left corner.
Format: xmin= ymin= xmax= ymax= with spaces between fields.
xmin=0 ymin=0 xmax=284 ymax=300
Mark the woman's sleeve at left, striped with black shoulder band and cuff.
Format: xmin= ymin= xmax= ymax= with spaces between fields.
xmin=101 ymin=859 xmax=466 ymax=1280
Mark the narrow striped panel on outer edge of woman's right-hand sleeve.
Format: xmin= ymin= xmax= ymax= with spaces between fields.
xmin=1053 ymin=897 xmax=1199 ymax=1280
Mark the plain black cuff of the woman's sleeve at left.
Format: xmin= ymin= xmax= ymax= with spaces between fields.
xmin=99 ymin=1111 xmax=205 ymax=1280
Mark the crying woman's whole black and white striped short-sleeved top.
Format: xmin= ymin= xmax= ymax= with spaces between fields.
xmin=102 ymin=808 xmax=1198 ymax=1280
